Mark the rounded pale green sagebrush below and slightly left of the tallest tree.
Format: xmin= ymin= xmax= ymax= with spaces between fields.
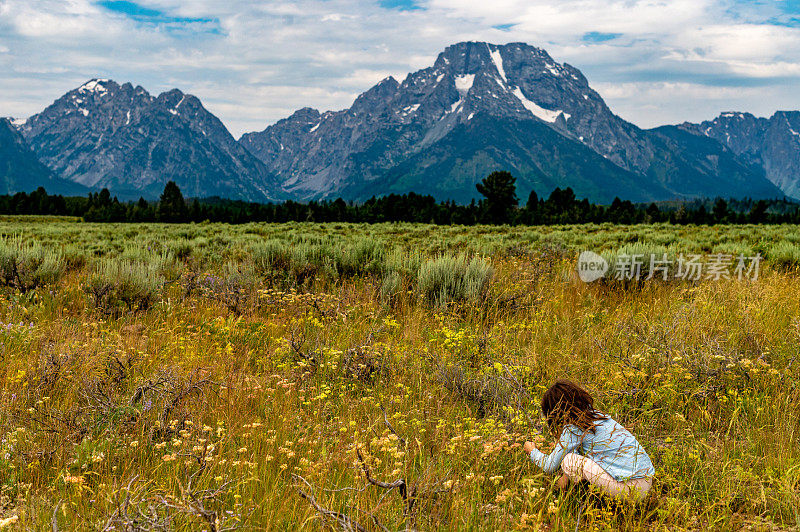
xmin=417 ymin=255 xmax=494 ymax=307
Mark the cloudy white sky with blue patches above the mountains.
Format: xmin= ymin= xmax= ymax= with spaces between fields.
xmin=0 ymin=0 xmax=800 ymax=137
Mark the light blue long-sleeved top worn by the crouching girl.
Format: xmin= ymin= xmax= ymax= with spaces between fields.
xmin=531 ymin=417 xmax=656 ymax=482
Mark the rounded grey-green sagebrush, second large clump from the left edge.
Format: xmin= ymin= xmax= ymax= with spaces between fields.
xmin=84 ymin=259 xmax=164 ymax=316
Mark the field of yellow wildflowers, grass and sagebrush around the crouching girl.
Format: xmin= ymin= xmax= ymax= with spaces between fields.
xmin=0 ymin=219 xmax=800 ymax=531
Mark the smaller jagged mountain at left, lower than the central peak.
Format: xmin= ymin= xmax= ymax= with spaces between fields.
xmin=20 ymin=79 xmax=282 ymax=201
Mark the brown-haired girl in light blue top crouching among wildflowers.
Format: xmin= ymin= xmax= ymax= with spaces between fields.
xmin=524 ymin=379 xmax=655 ymax=500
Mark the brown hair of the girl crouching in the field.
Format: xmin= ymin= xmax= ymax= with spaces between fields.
xmin=542 ymin=379 xmax=608 ymax=433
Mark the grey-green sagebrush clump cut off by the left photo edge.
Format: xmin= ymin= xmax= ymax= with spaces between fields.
xmin=0 ymin=239 xmax=66 ymax=292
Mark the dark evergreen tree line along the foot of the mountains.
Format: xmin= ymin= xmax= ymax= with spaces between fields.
xmin=0 ymin=171 xmax=800 ymax=225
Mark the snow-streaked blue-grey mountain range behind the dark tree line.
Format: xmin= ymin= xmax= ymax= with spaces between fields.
xmin=0 ymin=42 xmax=800 ymax=203
